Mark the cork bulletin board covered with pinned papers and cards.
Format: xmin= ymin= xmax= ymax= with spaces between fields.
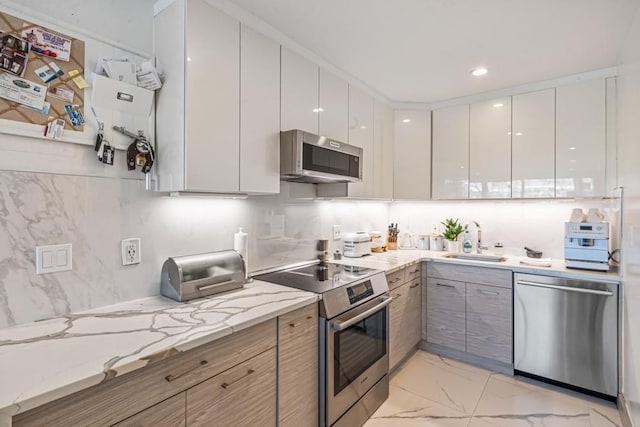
xmin=0 ymin=13 xmax=86 ymax=132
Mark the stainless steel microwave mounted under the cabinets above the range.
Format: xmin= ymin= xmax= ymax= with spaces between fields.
xmin=280 ymin=129 xmax=362 ymax=183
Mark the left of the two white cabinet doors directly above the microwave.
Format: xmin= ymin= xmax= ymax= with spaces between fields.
xmin=280 ymin=46 xmax=319 ymax=135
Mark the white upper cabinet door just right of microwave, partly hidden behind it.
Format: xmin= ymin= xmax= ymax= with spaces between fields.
xmin=348 ymin=86 xmax=373 ymax=198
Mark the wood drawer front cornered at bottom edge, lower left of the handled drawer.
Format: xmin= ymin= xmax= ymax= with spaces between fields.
xmin=113 ymin=392 xmax=187 ymax=427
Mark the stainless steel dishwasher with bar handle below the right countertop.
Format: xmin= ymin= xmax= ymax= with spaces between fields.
xmin=513 ymin=274 xmax=618 ymax=398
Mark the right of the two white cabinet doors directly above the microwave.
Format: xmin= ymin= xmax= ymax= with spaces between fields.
xmin=318 ymin=68 xmax=349 ymax=142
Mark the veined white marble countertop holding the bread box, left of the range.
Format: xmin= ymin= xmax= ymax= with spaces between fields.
xmin=0 ymin=281 xmax=318 ymax=427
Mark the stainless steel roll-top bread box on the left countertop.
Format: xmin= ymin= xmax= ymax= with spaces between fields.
xmin=160 ymin=250 xmax=246 ymax=301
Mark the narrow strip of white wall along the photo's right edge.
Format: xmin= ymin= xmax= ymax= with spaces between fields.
xmin=618 ymin=0 xmax=640 ymax=426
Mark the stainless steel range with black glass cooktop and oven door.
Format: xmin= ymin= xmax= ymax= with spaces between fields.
xmin=254 ymin=263 xmax=391 ymax=427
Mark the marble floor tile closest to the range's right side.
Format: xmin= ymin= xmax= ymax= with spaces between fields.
xmin=391 ymin=351 xmax=491 ymax=415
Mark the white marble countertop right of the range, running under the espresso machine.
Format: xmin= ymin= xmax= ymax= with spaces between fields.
xmin=334 ymin=249 xmax=621 ymax=284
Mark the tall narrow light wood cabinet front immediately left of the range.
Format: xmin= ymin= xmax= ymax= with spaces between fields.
xmin=278 ymin=304 xmax=319 ymax=427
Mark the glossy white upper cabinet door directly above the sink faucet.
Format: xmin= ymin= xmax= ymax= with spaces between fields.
xmin=469 ymin=98 xmax=511 ymax=199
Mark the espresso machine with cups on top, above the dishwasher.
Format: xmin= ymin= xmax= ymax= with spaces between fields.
xmin=564 ymin=222 xmax=609 ymax=271
